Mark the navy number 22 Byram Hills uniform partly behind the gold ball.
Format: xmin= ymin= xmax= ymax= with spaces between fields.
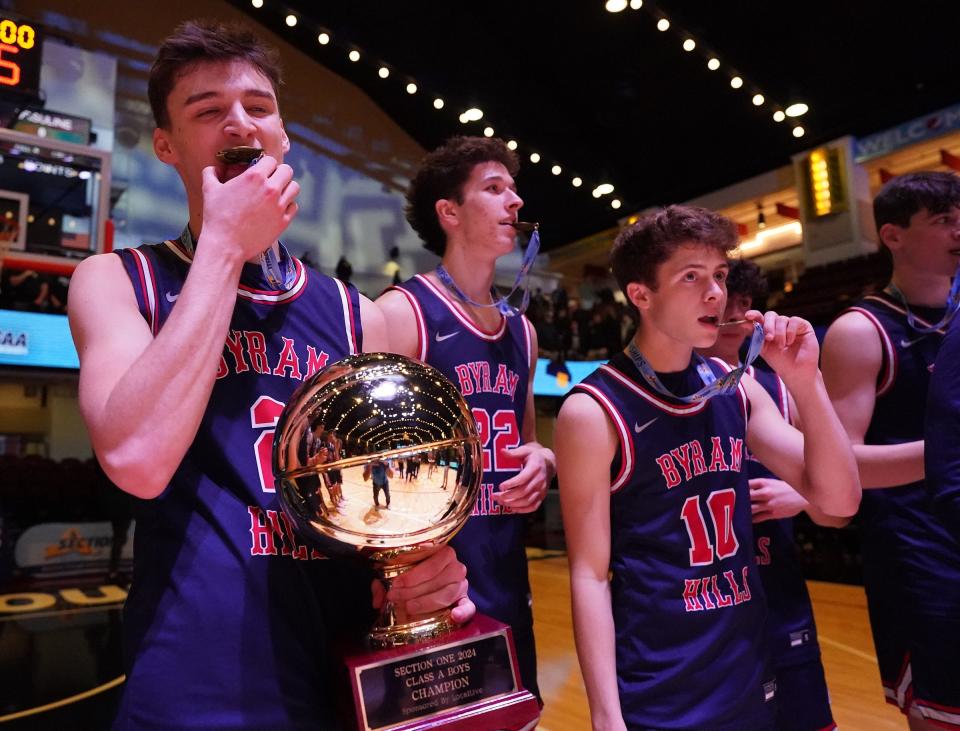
xmin=396 ymin=275 xmax=539 ymax=695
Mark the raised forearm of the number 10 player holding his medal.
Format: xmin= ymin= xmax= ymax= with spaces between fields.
xmin=786 ymin=371 xmax=861 ymax=517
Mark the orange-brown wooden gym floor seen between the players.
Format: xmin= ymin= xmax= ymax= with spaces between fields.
xmin=528 ymin=549 xmax=907 ymax=731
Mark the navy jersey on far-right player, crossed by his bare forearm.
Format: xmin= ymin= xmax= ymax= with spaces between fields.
xmin=848 ymin=292 xmax=960 ymax=615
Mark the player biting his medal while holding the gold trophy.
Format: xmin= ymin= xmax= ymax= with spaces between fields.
xmin=70 ymin=22 xmax=472 ymax=730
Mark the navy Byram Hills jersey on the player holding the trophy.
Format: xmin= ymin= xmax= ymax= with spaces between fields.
xmin=116 ymin=241 xmax=369 ymax=729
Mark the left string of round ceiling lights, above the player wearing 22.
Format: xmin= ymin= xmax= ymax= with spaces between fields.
xmin=244 ymin=0 xmax=623 ymax=210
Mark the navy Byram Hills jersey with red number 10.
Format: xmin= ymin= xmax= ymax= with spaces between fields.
xmin=572 ymin=353 xmax=775 ymax=731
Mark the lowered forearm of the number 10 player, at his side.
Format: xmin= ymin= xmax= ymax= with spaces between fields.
xmin=570 ymin=569 xmax=623 ymax=731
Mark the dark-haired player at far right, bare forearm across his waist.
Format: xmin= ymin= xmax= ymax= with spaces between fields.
xmin=823 ymin=172 xmax=960 ymax=729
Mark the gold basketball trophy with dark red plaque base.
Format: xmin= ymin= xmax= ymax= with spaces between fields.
xmin=273 ymin=353 xmax=539 ymax=731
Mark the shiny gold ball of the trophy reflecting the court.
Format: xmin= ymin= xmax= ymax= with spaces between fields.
xmin=273 ymin=353 xmax=483 ymax=566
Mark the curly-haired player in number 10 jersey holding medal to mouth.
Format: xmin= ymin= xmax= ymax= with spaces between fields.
xmin=555 ymin=206 xmax=860 ymax=731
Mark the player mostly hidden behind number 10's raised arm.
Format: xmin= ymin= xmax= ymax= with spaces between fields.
xmin=697 ymin=259 xmax=849 ymax=731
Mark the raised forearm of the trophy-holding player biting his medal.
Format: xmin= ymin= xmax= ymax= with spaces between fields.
xmin=91 ymin=249 xmax=240 ymax=498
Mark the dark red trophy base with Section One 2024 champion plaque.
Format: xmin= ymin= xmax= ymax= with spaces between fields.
xmin=345 ymin=614 xmax=540 ymax=731
